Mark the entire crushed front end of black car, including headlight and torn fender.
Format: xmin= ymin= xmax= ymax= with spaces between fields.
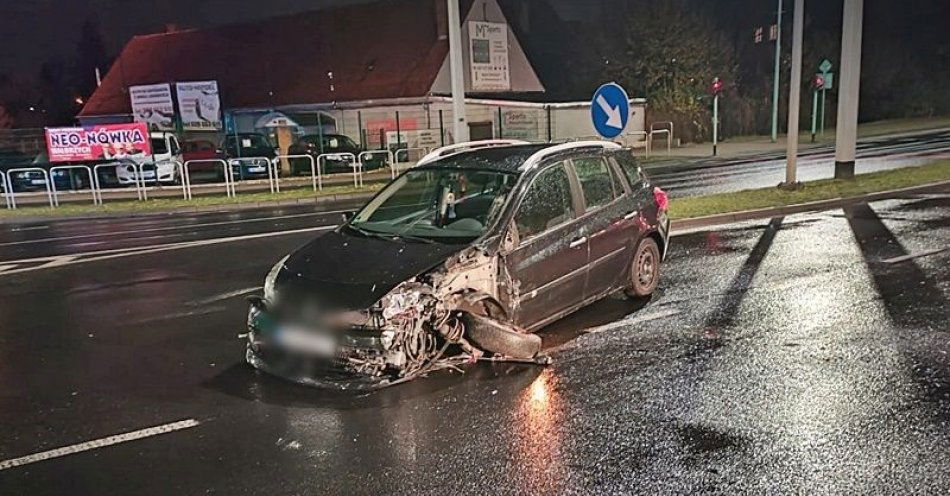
xmin=246 ymin=246 xmax=547 ymax=390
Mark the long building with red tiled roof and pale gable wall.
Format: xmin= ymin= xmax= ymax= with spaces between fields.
xmin=78 ymin=0 xmax=572 ymax=146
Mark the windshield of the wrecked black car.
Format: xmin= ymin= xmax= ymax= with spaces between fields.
xmin=348 ymin=168 xmax=518 ymax=243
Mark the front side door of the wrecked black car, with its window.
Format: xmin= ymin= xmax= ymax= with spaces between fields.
xmin=504 ymin=162 xmax=587 ymax=328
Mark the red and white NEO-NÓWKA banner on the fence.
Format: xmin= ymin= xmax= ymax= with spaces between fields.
xmin=46 ymin=122 xmax=152 ymax=162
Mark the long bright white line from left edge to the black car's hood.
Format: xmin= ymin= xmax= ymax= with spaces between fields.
xmin=0 ymin=225 xmax=337 ymax=277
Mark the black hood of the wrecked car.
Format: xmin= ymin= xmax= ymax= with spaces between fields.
xmin=276 ymin=229 xmax=468 ymax=310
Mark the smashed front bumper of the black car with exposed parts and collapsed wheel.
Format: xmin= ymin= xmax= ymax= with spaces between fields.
xmin=245 ymin=285 xmax=550 ymax=390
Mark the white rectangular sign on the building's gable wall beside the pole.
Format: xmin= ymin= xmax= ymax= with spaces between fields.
xmin=468 ymin=21 xmax=511 ymax=91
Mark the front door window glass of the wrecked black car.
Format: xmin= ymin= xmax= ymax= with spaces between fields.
xmin=515 ymin=163 xmax=574 ymax=240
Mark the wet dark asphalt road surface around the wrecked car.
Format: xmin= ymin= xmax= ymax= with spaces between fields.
xmin=0 ymin=190 xmax=950 ymax=495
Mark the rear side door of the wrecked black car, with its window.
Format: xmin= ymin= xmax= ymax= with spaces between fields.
xmin=571 ymin=153 xmax=638 ymax=298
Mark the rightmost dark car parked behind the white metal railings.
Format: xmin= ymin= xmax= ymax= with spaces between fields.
xmin=289 ymin=134 xmax=388 ymax=175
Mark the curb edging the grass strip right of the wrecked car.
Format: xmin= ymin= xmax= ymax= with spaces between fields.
xmin=671 ymin=181 xmax=950 ymax=233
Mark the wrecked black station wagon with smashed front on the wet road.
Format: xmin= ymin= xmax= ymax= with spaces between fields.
xmin=246 ymin=140 xmax=670 ymax=389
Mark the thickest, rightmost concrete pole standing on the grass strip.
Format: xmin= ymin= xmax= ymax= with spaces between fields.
xmin=835 ymin=0 xmax=864 ymax=179
